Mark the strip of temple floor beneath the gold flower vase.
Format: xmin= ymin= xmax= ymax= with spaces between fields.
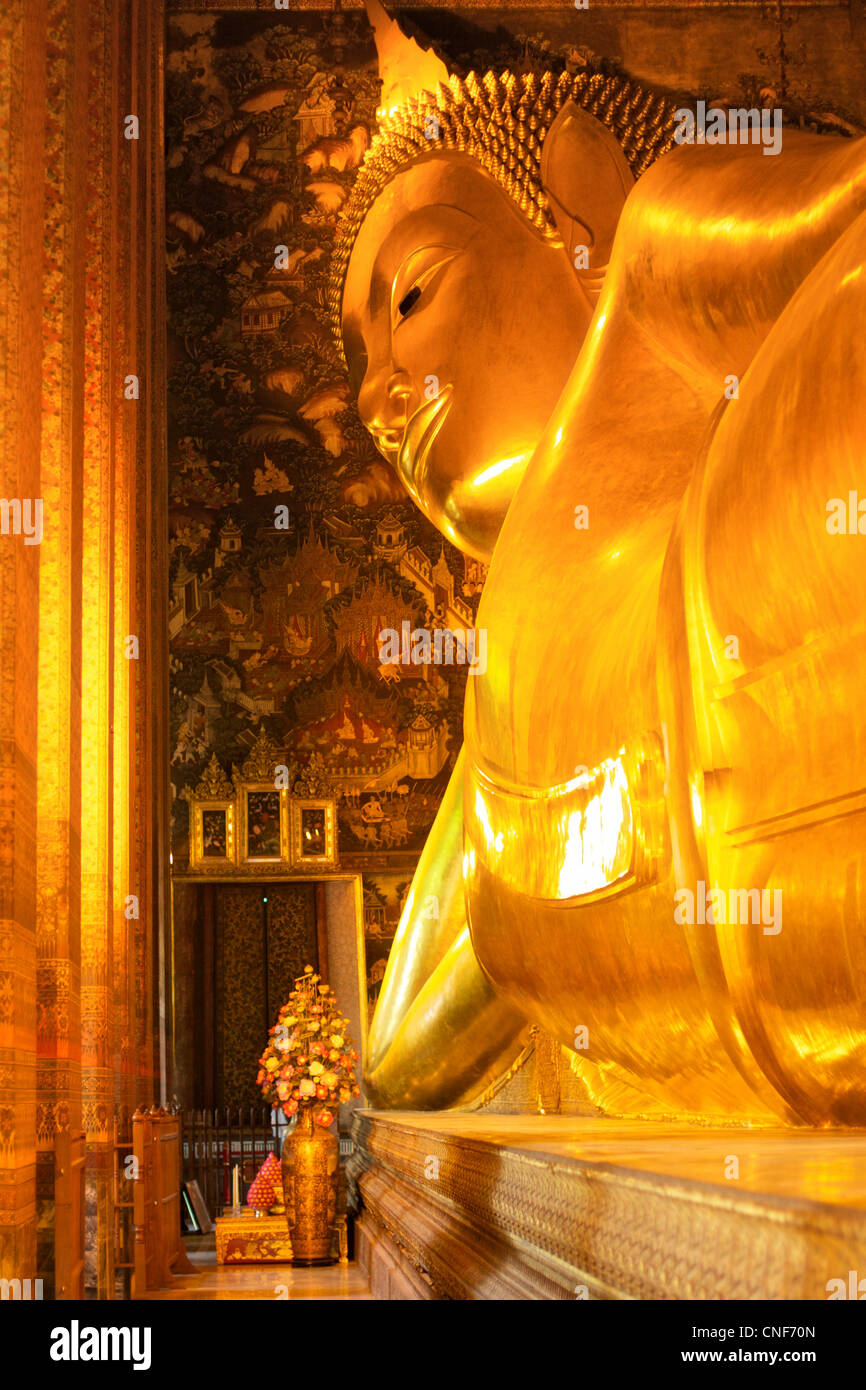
xmin=139 ymin=1234 xmax=373 ymax=1302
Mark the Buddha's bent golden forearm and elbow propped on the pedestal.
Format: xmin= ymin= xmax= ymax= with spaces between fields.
xmin=366 ymin=752 xmax=525 ymax=1109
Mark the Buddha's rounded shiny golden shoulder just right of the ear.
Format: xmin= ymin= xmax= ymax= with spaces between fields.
xmin=607 ymin=131 xmax=866 ymax=373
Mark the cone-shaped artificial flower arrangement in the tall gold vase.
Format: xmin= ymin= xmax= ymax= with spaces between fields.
xmin=256 ymin=965 xmax=361 ymax=1126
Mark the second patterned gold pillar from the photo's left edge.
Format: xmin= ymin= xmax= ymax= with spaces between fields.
xmin=36 ymin=0 xmax=88 ymax=1276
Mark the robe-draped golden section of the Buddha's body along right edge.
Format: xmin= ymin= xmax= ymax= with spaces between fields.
xmin=666 ymin=201 xmax=866 ymax=1125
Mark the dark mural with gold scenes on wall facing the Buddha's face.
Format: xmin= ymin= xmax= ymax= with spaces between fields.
xmin=167 ymin=14 xmax=484 ymax=869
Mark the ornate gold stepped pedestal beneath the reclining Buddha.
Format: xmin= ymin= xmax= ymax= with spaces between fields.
xmin=352 ymin=1111 xmax=866 ymax=1301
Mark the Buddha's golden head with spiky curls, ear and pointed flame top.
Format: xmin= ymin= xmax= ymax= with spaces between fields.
xmin=331 ymin=6 xmax=673 ymax=560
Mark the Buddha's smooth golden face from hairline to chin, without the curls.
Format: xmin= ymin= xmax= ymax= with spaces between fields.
xmin=343 ymin=154 xmax=592 ymax=560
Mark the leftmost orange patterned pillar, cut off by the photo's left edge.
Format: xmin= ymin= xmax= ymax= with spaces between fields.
xmin=0 ymin=0 xmax=47 ymax=1279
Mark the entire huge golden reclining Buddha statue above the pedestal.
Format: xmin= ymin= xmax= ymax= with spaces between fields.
xmin=331 ymin=0 xmax=866 ymax=1125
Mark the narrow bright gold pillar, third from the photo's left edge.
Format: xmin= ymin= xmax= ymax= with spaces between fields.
xmin=81 ymin=0 xmax=118 ymax=1297
